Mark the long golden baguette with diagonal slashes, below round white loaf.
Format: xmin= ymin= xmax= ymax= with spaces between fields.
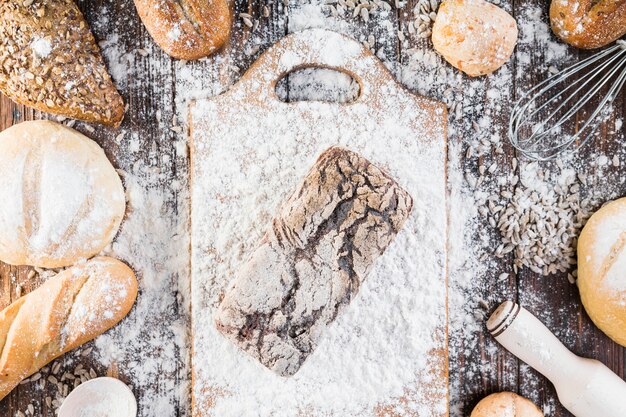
xmin=0 ymin=257 xmax=137 ymax=399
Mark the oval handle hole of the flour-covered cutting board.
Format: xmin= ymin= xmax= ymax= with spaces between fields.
xmin=276 ymin=67 xmax=361 ymax=104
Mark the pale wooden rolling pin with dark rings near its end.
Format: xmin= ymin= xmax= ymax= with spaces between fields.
xmin=487 ymin=301 xmax=626 ymax=417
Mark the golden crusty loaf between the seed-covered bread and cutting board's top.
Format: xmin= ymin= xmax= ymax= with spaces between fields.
xmin=135 ymin=0 xmax=231 ymax=60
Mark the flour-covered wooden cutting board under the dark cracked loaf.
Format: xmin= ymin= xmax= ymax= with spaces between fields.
xmin=190 ymin=30 xmax=448 ymax=417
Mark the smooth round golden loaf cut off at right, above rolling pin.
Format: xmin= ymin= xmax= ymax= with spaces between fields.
xmin=578 ymin=198 xmax=626 ymax=346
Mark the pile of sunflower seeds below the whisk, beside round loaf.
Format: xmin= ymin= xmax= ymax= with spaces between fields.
xmin=479 ymin=163 xmax=592 ymax=276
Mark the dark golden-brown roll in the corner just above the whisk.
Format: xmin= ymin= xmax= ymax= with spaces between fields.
xmin=550 ymin=0 xmax=626 ymax=49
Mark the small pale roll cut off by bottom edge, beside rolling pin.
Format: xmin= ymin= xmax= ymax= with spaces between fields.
xmin=470 ymin=392 xmax=544 ymax=417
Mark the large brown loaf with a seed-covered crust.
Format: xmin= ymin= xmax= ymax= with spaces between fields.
xmin=0 ymin=0 xmax=124 ymax=126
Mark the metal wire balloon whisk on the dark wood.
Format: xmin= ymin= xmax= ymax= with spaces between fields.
xmin=509 ymin=40 xmax=626 ymax=161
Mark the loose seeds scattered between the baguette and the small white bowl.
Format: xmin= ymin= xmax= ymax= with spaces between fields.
xmin=16 ymin=348 xmax=98 ymax=417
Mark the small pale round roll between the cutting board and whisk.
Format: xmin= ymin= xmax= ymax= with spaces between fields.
xmin=432 ymin=0 xmax=518 ymax=76
